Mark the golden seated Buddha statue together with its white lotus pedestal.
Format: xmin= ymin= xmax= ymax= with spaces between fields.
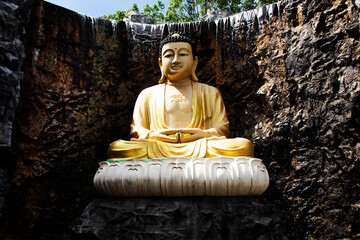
xmin=94 ymin=33 xmax=269 ymax=197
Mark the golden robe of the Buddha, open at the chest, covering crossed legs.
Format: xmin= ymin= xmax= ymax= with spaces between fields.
xmin=108 ymin=82 xmax=254 ymax=159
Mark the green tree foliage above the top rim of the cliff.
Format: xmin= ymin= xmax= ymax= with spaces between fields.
xmin=102 ymin=0 xmax=276 ymax=22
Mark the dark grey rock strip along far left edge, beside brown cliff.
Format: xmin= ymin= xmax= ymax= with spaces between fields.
xmin=0 ymin=0 xmax=32 ymax=223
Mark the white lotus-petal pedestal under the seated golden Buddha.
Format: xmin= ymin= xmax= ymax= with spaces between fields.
xmin=94 ymin=157 xmax=269 ymax=197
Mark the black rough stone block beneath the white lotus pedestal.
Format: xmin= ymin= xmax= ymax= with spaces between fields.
xmin=74 ymin=197 xmax=287 ymax=240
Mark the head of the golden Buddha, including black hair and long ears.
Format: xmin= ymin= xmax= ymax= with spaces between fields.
xmin=159 ymin=33 xmax=198 ymax=83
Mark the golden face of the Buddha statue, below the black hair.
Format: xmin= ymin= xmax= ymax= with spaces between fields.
xmin=159 ymin=42 xmax=197 ymax=81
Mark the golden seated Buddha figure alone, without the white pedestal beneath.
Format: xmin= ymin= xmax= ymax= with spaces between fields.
xmin=108 ymin=33 xmax=254 ymax=160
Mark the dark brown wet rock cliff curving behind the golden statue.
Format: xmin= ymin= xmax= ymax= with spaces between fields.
xmin=0 ymin=0 xmax=360 ymax=239
